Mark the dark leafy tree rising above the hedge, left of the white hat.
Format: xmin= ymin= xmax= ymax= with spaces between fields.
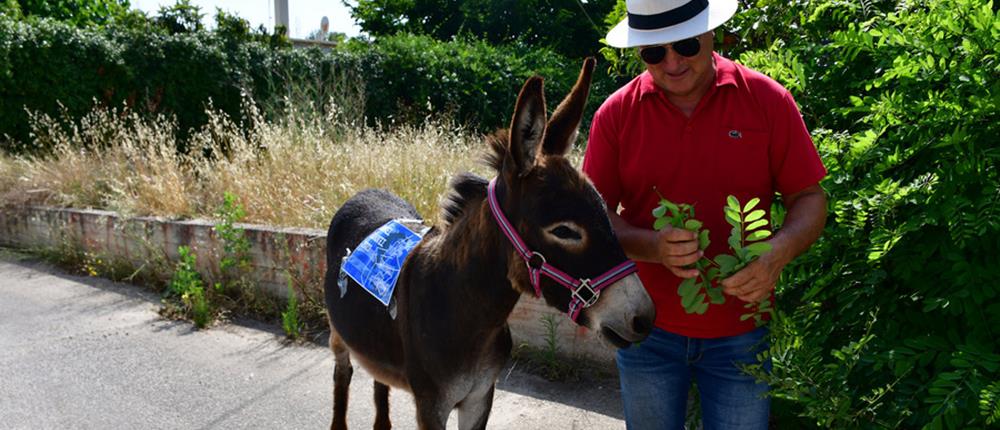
xmin=345 ymin=0 xmax=615 ymax=58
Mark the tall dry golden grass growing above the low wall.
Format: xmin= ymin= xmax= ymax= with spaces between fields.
xmin=0 ymin=101 xmax=488 ymax=228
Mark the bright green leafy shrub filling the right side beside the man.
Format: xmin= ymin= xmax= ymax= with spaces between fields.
xmin=716 ymin=0 xmax=1000 ymax=429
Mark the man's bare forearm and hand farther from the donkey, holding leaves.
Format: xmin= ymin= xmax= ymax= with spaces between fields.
xmin=720 ymin=185 xmax=826 ymax=303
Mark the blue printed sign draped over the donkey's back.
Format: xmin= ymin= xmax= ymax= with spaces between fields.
xmin=340 ymin=220 xmax=422 ymax=306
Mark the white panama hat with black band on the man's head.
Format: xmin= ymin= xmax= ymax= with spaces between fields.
xmin=606 ymin=0 xmax=737 ymax=48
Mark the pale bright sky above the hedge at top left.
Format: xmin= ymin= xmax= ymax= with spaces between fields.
xmin=129 ymin=0 xmax=361 ymax=39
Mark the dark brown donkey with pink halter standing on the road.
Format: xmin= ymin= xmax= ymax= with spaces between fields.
xmin=324 ymin=58 xmax=654 ymax=429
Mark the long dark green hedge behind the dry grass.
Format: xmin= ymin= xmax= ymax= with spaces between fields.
xmin=0 ymin=17 xmax=615 ymax=155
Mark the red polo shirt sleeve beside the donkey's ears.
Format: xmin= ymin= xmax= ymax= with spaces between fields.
xmin=583 ymin=102 xmax=621 ymax=210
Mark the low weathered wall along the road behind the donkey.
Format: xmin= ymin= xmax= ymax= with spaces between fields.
xmin=0 ymin=207 xmax=614 ymax=368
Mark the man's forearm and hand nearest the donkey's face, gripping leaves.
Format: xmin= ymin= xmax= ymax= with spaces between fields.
xmin=608 ymin=210 xmax=703 ymax=278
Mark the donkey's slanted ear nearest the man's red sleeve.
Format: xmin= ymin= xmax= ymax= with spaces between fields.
xmin=542 ymin=57 xmax=594 ymax=155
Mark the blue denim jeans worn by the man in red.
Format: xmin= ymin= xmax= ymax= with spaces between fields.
xmin=618 ymin=327 xmax=771 ymax=430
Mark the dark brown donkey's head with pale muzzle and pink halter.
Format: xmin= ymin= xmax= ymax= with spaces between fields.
xmin=491 ymin=58 xmax=655 ymax=347
